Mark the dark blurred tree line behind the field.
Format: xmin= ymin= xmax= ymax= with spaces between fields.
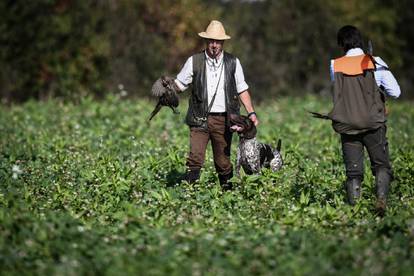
xmin=0 ymin=0 xmax=414 ymax=102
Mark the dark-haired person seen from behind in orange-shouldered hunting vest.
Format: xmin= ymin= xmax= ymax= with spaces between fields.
xmin=328 ymin=25 xmax=401 ymax=215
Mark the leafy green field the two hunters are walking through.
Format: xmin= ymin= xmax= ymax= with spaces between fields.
xmin=0 ymin=96 xmax=414 ymax=275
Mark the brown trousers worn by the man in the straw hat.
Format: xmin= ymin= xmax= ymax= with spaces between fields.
xmin=187 ymin=115 xmax=233 ymax=175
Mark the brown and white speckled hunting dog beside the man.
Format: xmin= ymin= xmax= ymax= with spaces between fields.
xmin=230 ymin=115 xmax=283 ymax=176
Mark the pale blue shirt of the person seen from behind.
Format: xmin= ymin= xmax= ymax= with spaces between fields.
xmin=330 ymin=48 xmax=401 ymax=98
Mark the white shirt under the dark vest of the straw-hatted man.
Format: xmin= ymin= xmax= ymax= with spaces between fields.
xmin=175 ymin=52 xmax=249 ymax=112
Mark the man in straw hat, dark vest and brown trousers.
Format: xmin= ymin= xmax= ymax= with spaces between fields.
xmin=175 ymin=20 xmax=259 ymax=190
